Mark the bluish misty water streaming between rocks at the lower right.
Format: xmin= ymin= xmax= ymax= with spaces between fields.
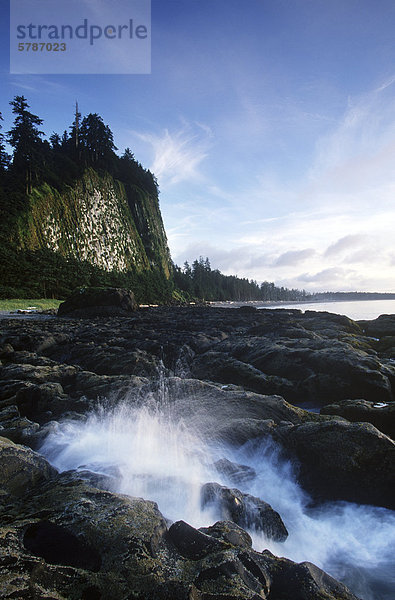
xmin=230 ymin=440 xmax=395 ymax=600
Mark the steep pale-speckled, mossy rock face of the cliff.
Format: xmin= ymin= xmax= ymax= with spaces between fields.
xmin=14 ymin=169 xmax=170 ymax=277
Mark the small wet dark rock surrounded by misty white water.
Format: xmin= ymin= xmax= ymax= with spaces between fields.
xmin=201 ymin=483 xmax=288 ymax=542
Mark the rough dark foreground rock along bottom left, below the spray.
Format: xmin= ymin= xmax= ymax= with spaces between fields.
xmin=0 ymin=442 xmax=364 ymax=600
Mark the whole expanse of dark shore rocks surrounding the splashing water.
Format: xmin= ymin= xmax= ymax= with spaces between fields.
xmin=0 ymin=307 xmax=395 ymax=600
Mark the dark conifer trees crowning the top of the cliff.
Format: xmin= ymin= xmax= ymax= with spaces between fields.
xmin=0 ymin=96 xmax=158 ymax=195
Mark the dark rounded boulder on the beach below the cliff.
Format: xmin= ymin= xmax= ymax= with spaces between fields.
xmin=58 ymin=288 xmax=138 ymax=318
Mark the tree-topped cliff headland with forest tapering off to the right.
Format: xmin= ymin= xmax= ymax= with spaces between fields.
xmin=0 ymin=96 xmax=316 ymax=303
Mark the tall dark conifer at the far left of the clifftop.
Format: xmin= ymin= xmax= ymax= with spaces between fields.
xmin=7 ymin=96 xmax=44 ymax=194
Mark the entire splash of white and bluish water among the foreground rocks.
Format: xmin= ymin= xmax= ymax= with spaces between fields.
xmin=40 ymin=392 xmax=395 ymax=600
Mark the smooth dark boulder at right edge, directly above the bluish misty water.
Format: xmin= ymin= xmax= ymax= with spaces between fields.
xmin=283 ymin=420 xmax=395 ymax=509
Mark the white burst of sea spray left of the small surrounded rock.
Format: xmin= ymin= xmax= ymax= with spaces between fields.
xmin=41 ymin=404 xmax=226 ymax=526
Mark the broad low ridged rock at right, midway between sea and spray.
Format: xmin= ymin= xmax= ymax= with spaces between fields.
xmin=207 ymin=336 xmax=393 ymax=405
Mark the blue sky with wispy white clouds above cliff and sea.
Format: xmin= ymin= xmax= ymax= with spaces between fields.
xmin=0 ymin=0 xmax=395 ymax=292
